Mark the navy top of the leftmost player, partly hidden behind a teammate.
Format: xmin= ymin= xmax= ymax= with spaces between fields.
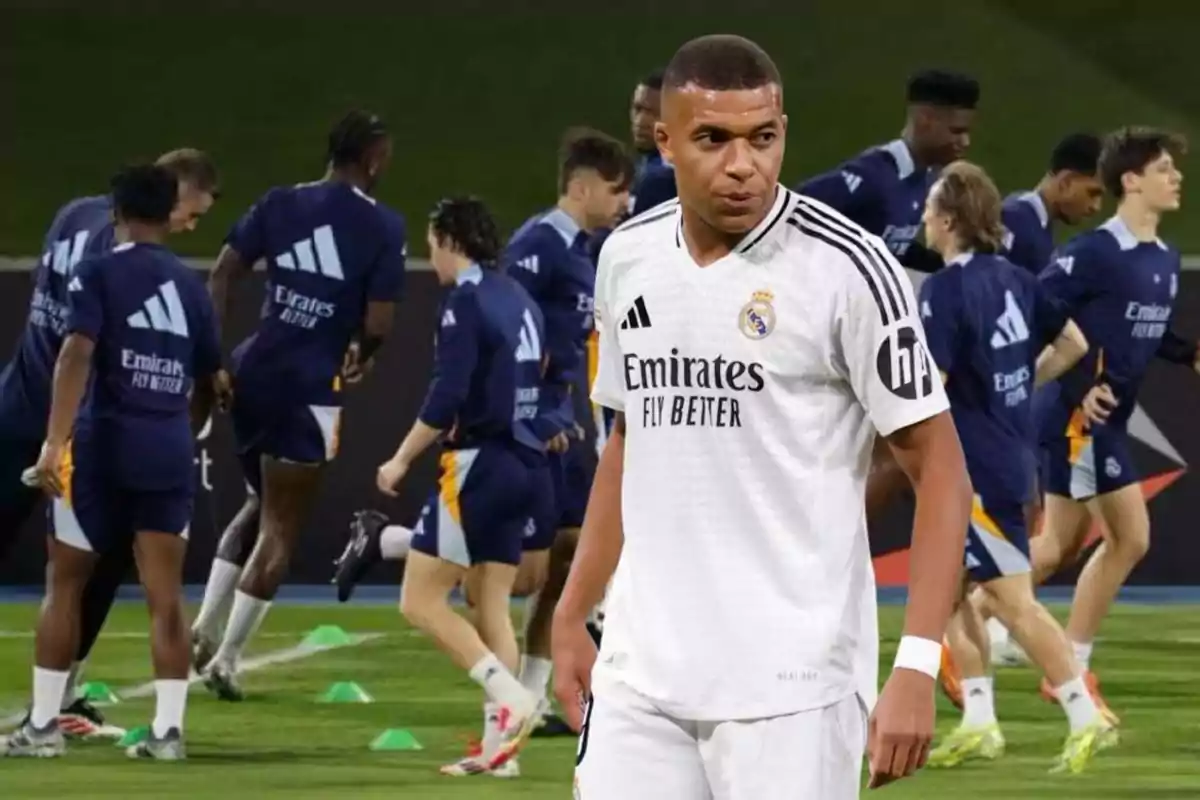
xmin=0 ymin=196 xmax=113 ymax=439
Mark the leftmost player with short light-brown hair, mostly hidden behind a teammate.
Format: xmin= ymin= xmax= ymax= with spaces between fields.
xmin=0 ymin=148 xmax=217 ymax=735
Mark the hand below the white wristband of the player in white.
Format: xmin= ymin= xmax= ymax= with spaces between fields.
xmin=866 ymin=668 xmax=936 ymax=789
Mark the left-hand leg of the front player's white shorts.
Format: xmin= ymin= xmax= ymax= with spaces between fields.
xmin=575 ymin=663 xmax=710 ymax=800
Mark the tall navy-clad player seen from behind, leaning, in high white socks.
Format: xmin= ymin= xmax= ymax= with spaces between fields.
xmin=193 ymin=112 xmax=404 ymax=700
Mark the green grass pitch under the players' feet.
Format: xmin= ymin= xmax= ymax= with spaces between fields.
xmin=0 ymin=603 xmax=1200 ymax=800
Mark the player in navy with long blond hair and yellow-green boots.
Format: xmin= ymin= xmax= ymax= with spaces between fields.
xmin=920 ymin=162 xmax=1116 ymax=772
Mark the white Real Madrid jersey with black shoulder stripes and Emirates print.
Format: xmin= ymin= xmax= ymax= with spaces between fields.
xmin=593 ymin=187 xmax=948 ymax=721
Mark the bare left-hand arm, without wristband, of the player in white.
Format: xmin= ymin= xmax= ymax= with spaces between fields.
xmin=550 ymin=414 xmax=625 ymax=730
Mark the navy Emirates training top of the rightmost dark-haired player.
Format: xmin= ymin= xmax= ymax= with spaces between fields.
xmin=1040 ymin=217 xmax=1181 ymax=433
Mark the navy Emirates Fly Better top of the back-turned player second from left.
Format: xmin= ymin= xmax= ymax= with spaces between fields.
xmin=68 ymin=242 xmax=221 ymax=489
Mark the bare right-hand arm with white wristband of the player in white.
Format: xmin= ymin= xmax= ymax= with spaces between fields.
xmin=870 ymin=411 xmax=972 ymax=788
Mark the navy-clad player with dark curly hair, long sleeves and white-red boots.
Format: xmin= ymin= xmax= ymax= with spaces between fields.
xmin=378 ymin=199 xmax=551 ymax=775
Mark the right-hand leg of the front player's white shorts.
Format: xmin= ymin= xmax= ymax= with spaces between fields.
xmin=700 ymin=694 xmax=866 ymax=800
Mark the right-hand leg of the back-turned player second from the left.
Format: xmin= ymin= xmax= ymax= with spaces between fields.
xmin=126 ymin=501 xmax=192 ymax=760
